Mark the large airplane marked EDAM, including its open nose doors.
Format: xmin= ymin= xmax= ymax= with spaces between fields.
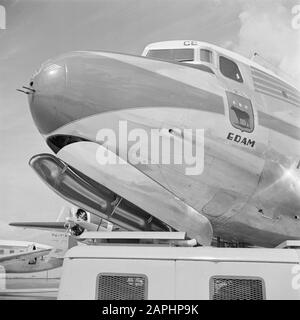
xmin=19 ymin=40 xmax=300 ymax=247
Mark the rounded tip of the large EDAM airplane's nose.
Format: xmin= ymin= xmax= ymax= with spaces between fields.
xmin=29 ymin=60 xmax=66 ymax=134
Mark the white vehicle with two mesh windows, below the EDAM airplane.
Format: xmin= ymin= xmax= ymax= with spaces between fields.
xmin=58 ymin=232 xmax=300 ymax=300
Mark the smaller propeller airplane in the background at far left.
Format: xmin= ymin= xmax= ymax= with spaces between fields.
xmin=0 ymin=206 xmax=94 ymax=273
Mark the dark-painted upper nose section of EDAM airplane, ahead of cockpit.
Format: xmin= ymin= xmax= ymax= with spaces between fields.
xmin=29 ymin=51 xmax=224 ymax=139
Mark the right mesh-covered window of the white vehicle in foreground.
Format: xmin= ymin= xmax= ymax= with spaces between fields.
xmin=210 ymin=276 xmax=265 ymax=300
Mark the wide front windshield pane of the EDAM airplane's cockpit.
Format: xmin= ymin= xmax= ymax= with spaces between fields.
xmin=147 ymin=49 xmax=194 ymax=62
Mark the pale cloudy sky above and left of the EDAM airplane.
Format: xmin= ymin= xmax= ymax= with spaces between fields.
xmin=0 ymin=0 xmax=300 ymax=240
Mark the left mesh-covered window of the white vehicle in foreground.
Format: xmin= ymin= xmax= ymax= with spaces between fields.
xmin=96 ymin=273 xmax=148 ymax=300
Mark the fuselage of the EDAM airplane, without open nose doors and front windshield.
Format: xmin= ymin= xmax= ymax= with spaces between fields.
xmin=25 ymin=41 xmax=300 ymax=246
